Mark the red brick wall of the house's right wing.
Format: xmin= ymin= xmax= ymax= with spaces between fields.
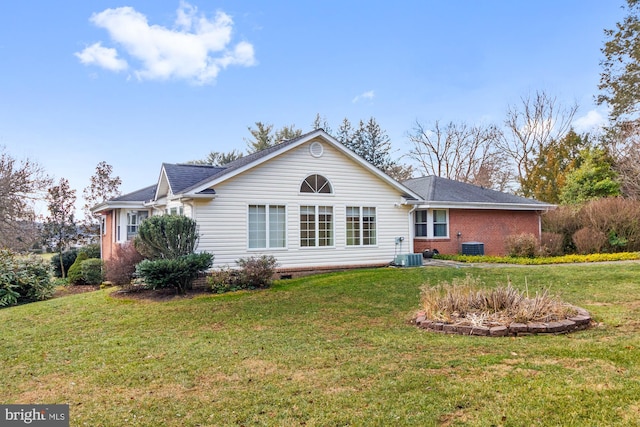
xmin=413 ymin=209 xmax=540 ymax=256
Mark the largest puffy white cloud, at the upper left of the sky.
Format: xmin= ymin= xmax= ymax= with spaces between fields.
xmin=76 ymin=1 xmax=256 ymax=84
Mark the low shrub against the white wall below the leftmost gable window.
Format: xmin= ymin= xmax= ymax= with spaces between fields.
xmin=207 ymin=255 xmax=278 ymax=294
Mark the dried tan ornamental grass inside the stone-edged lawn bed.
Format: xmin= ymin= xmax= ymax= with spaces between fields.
xmin=421 ymin=275 xmax=577 ymax=327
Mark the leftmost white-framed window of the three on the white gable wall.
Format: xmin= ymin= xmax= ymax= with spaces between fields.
xmin=249 ymin=205 xmax=287 ymax=249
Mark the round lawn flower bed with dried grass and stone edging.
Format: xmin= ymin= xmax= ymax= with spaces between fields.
xmin=412 ymin=276 xmax=591 ymax=337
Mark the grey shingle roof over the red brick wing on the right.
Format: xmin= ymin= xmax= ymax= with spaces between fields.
xmin=403 ymin=176 xmax=547 ymax=206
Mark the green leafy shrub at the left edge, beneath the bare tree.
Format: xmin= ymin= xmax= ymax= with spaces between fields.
xmin=0 ymin=249 xmax=54 ymax=306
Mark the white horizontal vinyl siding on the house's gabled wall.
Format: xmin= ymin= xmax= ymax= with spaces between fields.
xmin=192 ymin=141 xmax=411 ymax=268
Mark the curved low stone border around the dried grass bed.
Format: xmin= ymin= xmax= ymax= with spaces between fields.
xmin=412 ymin=307 xmax=591 ymax=337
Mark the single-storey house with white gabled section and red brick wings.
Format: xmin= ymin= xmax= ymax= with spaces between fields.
xmin=92 ymin=129 xmax=551 ymax=271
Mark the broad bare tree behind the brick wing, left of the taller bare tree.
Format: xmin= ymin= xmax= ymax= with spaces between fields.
xmin=408 ymin=121 xmax=509 ymax=189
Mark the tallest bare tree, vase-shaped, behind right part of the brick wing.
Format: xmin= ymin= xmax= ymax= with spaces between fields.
xmin=498 ymin=91 xmax=578 ymax=197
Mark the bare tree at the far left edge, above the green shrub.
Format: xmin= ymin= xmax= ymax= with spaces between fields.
xmin=0 ymin=147 xmax=51 ymax=250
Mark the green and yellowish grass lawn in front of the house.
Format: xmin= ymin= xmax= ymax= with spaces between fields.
xmin=0 ymin=262 xmax=640 ymax=426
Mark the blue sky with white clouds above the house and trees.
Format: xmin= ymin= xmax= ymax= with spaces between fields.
xmin=0 ymin=0 xmax=624 ymax=217
